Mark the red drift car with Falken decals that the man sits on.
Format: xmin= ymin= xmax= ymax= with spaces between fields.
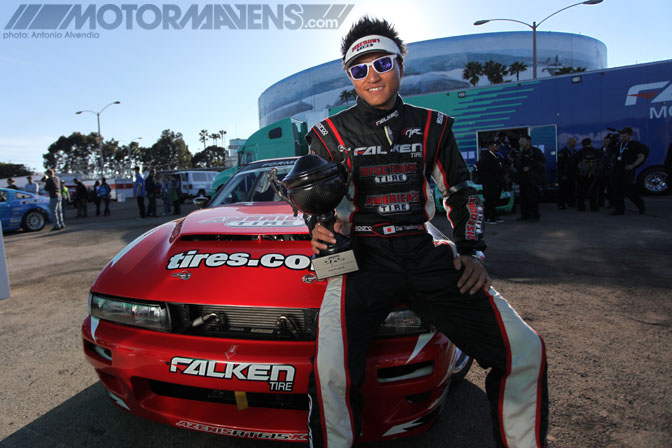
xmin=82 ymin=158 xmax=471 ymax=441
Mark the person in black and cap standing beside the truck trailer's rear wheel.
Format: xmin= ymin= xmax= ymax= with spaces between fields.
xmin=610 ymin=126 xmax=649 ymax=216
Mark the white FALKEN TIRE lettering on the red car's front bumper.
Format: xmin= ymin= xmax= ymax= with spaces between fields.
xmin=169 ymin=356 xmax=296 ymax=392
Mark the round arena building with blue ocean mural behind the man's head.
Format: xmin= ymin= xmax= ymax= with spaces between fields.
xmin=259 ymin=31 xmax=607 ymax=127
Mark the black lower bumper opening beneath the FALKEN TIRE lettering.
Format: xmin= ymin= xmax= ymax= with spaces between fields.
xmin=148 ymin=380 xmax=308 ymax=411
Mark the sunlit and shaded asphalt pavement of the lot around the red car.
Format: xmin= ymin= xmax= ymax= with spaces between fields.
xmin=0 ymin=196 xmax=672 ymax=448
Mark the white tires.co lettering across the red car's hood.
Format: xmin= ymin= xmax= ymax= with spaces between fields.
xmin=166 ymin=250 xmax=311 ymax=271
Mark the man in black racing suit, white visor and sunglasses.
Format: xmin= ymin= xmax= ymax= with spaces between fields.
xmin=306 ymin=18 xmax=548 ymax=448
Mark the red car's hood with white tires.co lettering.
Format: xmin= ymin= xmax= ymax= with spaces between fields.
xmin=92 ymin=202 xmax=326 ymax=308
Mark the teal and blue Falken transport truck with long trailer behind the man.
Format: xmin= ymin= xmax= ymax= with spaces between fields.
xmin=213 ymin=60 xmax=672 ymax=203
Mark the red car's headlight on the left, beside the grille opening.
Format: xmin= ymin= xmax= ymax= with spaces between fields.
xmin=89 ymin=294 xmax=171 ymax=331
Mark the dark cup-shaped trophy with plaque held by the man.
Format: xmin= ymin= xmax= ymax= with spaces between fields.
xmin=270 ymin=152 xmax=358 ymax=280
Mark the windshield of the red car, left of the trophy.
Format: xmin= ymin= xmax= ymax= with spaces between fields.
xmin=209 ymin=165 xmax=293 ymax=207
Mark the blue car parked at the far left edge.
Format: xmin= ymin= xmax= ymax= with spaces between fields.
xmin=0 ymin=188 xmax=50 ymax=232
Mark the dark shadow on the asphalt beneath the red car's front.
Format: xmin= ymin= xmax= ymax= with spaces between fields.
xmin=0 ymin=381 xmax=494 ymax=448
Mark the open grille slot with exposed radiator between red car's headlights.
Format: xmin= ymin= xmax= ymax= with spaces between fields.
xmin=170 ymin=304 xmax=318 ymax=341
